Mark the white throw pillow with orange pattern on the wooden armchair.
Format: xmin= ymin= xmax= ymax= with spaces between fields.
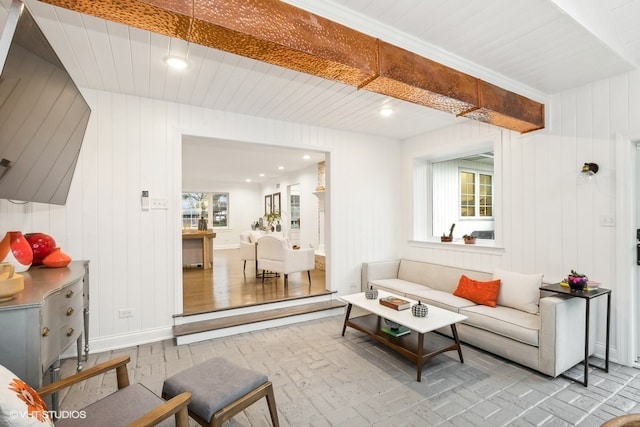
xmin=0 ymin=365 xmax=53 ymax=427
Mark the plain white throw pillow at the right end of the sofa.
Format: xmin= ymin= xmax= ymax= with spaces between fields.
xmin=493 ymin=269 xmax=542 ymax=314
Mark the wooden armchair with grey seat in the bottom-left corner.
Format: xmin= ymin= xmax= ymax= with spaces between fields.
xmin=37 ymin=356 xmax=191 ymax=427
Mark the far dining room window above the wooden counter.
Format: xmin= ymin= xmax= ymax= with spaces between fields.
xmin=182 ymin=193 xmax=229 ymax=230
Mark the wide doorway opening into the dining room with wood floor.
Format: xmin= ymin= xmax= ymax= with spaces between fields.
xmin=182 ymin=135 xmax=331 ymax=315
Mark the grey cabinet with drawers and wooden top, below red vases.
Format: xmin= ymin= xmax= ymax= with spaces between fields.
xmin=0 ymin=261 xmax=89 ymax=410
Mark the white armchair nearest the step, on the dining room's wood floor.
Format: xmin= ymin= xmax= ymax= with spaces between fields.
xmin=257 ymin=235 xmax=315 ymax=288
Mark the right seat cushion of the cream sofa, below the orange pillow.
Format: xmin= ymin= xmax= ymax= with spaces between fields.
xmin=459 ymin=305 xmax=540 ymax=347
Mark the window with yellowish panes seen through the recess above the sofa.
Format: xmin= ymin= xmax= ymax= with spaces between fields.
xmin=460 ymin=170 xmax=493 ymax=218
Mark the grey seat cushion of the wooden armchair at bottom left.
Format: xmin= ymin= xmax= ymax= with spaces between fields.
xmin=55 ymin=384 xmax=175 ymax=427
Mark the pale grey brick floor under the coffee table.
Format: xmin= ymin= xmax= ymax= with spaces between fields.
xmin=61 ymin=316 xmax=640 ymax=427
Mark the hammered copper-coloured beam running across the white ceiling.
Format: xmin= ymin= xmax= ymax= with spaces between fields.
xmin=40 ymin=0 xmax=544 ymax=132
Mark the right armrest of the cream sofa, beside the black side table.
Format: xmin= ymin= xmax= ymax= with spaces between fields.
xmin=539 ymin=294 xmax=597 ymax=377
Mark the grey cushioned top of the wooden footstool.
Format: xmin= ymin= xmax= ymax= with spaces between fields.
xmin=162 ymin=357 xmax=268 ymax=420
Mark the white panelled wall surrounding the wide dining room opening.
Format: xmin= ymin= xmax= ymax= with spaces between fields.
xmin=0 ymin=90 xmax=400 ymax=351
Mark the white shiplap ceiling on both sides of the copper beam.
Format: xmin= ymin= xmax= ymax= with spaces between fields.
xmin=0 ymin=0 xmax=640 ymax=182
